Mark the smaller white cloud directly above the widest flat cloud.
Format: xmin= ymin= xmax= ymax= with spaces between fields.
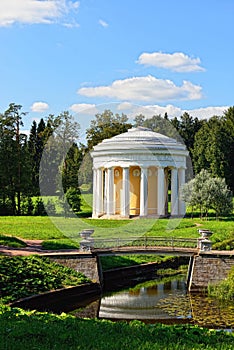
xmin=137 ymin=52 xmax=205 ymax=73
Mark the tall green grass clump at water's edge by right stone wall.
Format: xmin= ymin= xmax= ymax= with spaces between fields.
xmin=208 ymin=267 xmax=234 ymax=300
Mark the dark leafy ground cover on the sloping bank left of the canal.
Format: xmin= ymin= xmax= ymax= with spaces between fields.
xmin=0 ymin=255 xmax=87 ymax=300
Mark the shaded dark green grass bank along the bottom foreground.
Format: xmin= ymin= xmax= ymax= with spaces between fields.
xmin=0 ymin=306 xmax=234 ymax=350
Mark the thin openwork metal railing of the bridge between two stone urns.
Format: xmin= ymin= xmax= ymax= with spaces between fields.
xmin=93 ymin=236 xmax=197 ymax=249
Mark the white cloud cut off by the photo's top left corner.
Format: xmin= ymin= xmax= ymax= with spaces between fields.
xmin=0 ymin=0 xmax=79 ymax=26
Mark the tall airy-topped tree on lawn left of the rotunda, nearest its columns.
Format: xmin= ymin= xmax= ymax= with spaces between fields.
xmin=40 ymin=111 xmax=80 ymax=197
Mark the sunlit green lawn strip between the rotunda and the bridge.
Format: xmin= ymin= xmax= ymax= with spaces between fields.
xmin=0 ymin=216 xmax=234 ymax=249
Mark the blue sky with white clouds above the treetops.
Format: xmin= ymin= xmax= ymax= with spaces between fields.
xmin=0 ymin=0 xmax=234 ymax=139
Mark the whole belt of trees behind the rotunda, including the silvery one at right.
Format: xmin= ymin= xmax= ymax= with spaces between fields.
xmin=0 ymin=103 xmax=234 ymax=216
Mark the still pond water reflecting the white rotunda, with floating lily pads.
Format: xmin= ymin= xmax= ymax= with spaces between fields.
xmin=71 ymin=278 xmax=234 ymax=329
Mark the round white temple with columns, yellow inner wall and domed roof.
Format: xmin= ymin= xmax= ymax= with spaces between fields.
xmin=91 ymin=127 xmax=188 ymax=218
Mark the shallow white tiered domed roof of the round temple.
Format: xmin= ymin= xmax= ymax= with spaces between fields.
xmin=94 ymin=126 xmax=185 ymax=152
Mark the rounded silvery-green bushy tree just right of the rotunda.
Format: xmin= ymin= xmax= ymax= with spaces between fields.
xmin=181 ymin=169 xmax=233 ymax=217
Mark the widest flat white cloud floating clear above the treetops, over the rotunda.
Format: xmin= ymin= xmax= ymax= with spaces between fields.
xmin=78 ymin=75 xmax=202 ymax=102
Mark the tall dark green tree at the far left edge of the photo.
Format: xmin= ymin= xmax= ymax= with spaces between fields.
xmin=0 ymin=103 xmax=30 ymax=215
